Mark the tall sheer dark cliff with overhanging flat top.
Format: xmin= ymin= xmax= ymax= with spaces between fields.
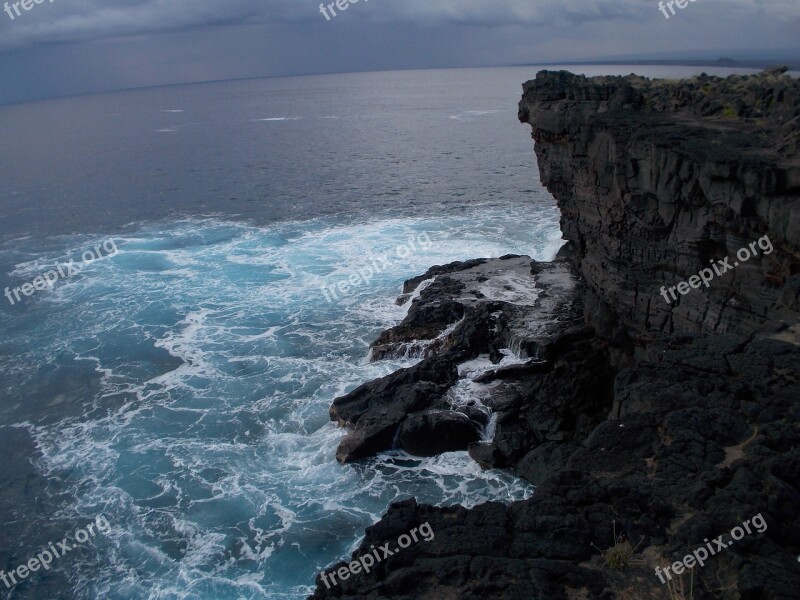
xmin=519 ymin=70 xmax=800 ymax=335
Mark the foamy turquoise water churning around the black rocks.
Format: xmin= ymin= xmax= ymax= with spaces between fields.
xmin=0 ymin=205 xmax=560 ymax=600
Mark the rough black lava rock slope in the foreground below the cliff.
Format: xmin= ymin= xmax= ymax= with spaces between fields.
xmin=314 ymin=334 xmax=800 ymax=600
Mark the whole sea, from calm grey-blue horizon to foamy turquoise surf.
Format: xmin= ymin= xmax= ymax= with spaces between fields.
xmin=0 ymin=67 xmax=756 ymax=600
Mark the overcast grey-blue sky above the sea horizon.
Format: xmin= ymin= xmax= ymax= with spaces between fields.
xmin=0 ymin=0 xmax=800 ymax=103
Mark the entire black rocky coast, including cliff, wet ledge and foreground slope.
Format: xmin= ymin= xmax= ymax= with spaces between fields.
xmin=312 ymin=70 xmax=800 ymax=600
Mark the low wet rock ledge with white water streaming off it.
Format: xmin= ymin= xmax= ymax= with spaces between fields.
xmin=330 ymin=256 xmax=581 ymax=463
